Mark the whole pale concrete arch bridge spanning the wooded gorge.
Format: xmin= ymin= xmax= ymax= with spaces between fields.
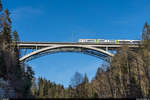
xmin=17 ymin=42 xmax=138 ymax=62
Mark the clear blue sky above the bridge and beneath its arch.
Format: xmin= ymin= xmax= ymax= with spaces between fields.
xmin=2 ymin=0 xmax=150 ymax=86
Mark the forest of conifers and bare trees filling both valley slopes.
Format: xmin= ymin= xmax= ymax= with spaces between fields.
xmin=0 ymin=0 xmax=150 ymax=98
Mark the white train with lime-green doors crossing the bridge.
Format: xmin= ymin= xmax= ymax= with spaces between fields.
xmin=78 ymin=39 xmax=140 ymax=44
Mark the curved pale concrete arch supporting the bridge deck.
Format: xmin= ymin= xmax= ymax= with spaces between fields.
xmin=19 ymin=45 xmax=114 ymax=62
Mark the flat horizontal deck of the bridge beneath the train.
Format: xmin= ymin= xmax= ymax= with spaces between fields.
xmin=18 ymin=42 xmax=139 ymax=49
